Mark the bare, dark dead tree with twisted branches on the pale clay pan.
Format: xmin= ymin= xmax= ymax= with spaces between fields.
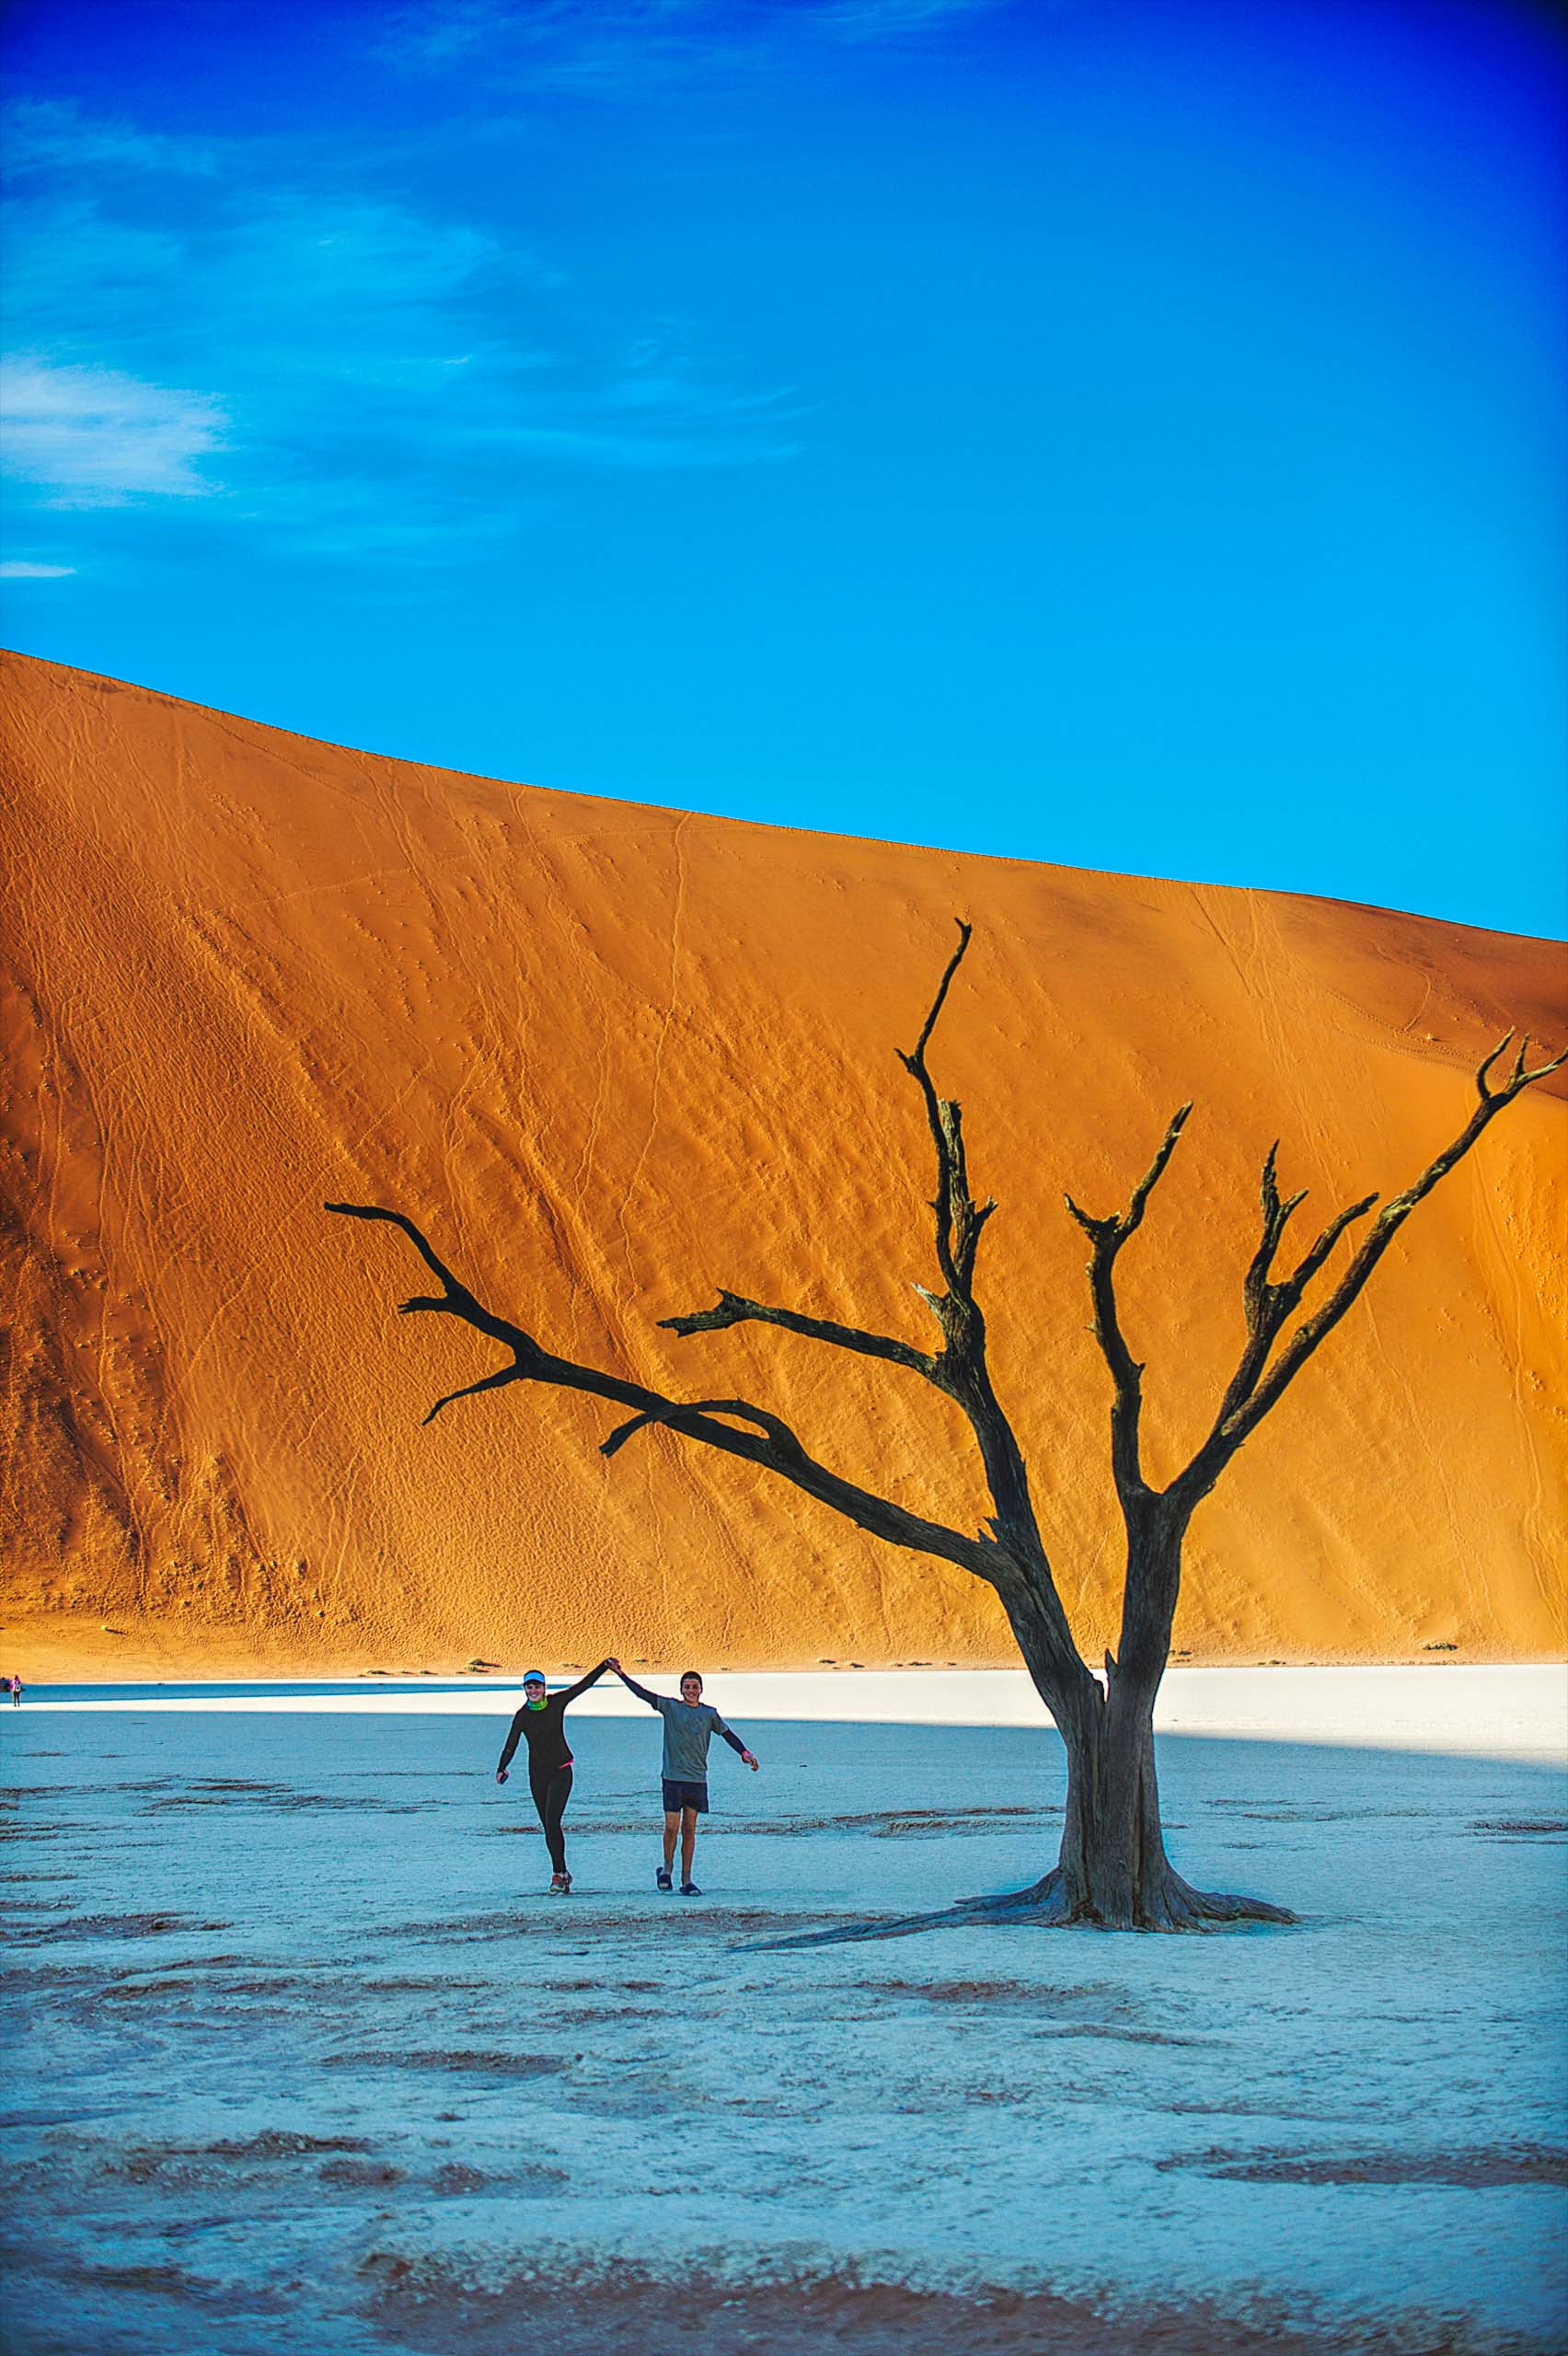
xmin=328 ymin=924 xmax=1568 ymax=1930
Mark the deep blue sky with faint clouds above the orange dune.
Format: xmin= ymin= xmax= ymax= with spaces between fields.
xmin=3 ymin=0 xmax=1568 ymax=933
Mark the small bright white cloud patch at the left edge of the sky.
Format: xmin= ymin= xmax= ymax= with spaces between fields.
xmin=0 ymin=353 xmax=226 ymax=506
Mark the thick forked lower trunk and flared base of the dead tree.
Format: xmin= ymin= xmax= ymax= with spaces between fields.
xmin=974 ymin=1513 xmax=1295 ymax=1930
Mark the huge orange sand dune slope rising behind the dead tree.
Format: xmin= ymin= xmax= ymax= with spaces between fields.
xmin=0 ymin=657 xmax=1568 ymax=1668
